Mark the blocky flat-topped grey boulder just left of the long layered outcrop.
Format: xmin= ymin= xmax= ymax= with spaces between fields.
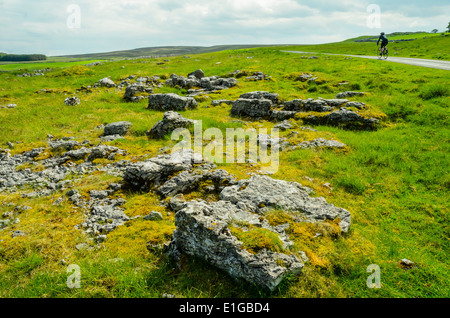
xmin=147 ymin=93 xmax=198 ymax=111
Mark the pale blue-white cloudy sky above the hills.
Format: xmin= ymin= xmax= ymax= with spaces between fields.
xmin=0 ymin=0 xmax=450 ymax=56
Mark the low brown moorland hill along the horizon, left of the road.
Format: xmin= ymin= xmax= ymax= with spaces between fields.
xmin=58 ymin=44 xmax=280 ymax=59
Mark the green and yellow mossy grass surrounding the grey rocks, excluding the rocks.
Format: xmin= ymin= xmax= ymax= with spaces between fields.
xmin=0 ymin=37 xmax=450 ymax=298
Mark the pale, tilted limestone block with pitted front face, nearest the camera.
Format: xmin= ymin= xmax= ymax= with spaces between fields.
xmin=169 ymin=201 xmax=304 ymax=290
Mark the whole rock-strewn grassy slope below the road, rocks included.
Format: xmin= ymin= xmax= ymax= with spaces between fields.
xmin=0 ymin=42 xmax=450 ymax=298
